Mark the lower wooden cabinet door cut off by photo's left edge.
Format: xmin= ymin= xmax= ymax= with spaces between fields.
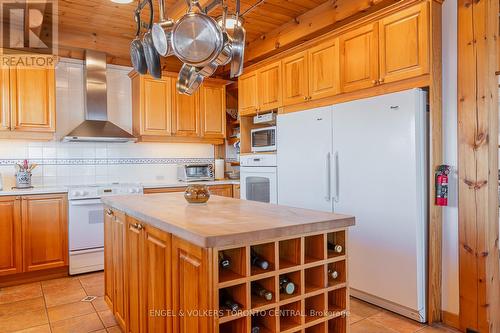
xmin=0 ymin=197 xmax=23 ymax=276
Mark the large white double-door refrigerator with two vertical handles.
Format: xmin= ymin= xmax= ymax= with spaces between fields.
xmin=277 ymin=89 xmax=428 ymax=322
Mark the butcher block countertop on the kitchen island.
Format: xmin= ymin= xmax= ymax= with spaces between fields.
xmin=102 ymin=193 xmax=354 ymax=248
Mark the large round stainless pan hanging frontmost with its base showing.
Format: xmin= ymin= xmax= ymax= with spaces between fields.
xmin=172 ymin=0 xmax=224 ymax=67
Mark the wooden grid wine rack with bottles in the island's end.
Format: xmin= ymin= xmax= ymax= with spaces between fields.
xmin=213 ymin=229 xmax=349 ymax=333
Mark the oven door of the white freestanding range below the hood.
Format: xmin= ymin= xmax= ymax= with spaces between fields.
xmin=69 ymin=199 xmax=104 ymax=252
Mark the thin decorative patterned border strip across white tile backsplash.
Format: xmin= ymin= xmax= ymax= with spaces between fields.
xmin=0 ymin=158 xmax=214 ymax=166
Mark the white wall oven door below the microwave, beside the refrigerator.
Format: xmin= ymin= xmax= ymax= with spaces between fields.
xmin=240 ymin=167 xmax=278 ymax=204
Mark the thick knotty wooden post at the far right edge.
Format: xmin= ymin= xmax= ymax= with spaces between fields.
xmin=458 ymin=0 xmax=500 ymax=333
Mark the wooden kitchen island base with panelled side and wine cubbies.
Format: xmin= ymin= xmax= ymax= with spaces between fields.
xmin=101 ymin=194 xmax=354 ymax=333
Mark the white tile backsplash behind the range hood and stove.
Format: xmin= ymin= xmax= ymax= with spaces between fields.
xmin=0 ymin=59 xmax=214 ymax=189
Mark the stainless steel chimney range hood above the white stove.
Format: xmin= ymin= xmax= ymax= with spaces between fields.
xmin=62 ymin=50 xmax=136 ymax=142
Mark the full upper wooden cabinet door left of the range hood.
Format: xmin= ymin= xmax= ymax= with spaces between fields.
xmin=10 ymin=68 xmax=56 ymax=132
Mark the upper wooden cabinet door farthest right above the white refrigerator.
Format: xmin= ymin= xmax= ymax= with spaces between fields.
xmin=379 ymin=2 xmax=429 ymax=82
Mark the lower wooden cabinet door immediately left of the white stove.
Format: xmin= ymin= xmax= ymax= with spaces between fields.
xmin=22 ymin=195 xmax=68 ymax=272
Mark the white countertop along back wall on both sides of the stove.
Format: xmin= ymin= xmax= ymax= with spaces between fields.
xmin=0 ymin=179 xmax=240 ymax=196
